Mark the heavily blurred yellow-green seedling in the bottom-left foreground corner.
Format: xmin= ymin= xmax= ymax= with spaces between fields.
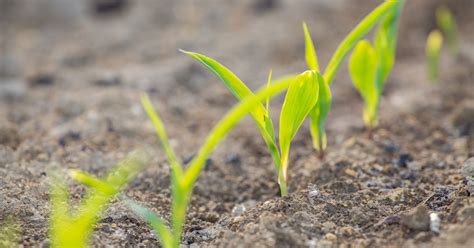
xmin=50 ymin=151 xmax=148 ymax=247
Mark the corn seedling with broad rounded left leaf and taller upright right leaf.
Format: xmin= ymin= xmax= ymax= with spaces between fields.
xmin=349 ymin=1 xmax=402 ymax=130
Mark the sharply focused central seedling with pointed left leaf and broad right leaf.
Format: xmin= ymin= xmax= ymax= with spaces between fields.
xmin=182 ymin=51 xmax=322 ymax=196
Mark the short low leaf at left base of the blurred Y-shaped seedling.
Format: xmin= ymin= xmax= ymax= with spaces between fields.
xmin=122 ymin=197 xmax=174 ymax=248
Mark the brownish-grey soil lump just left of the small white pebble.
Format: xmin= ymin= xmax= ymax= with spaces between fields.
xmin=400 ymin=205 xmax=430 ymax=232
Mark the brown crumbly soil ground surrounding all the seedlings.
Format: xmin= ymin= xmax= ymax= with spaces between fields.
xmin=0 ymin=0 xmax=474 ymax=247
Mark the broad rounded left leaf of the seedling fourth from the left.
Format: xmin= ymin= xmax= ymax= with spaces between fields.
xmin=349 ymin=40 xmax=382 ymax=127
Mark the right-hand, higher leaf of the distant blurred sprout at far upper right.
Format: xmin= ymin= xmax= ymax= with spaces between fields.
xmin=436 ymin=6 xmax=459 ymax=57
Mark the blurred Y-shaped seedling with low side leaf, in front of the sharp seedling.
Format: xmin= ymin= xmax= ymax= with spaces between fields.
xmin=124 ymin=78 xmax=293 ymax=247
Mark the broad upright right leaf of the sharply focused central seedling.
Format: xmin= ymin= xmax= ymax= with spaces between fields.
xmin=279 ymin=71 xmax=319 ymax=186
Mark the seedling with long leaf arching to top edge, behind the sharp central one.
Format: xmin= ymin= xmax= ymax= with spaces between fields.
xmin=303 ymin=0 xmax=403 ymax=153
